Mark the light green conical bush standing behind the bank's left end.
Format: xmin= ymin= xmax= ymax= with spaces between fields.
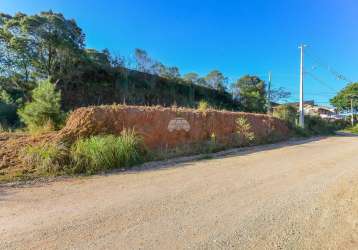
xmin=18 ymin=80 xmax=64 ymax=131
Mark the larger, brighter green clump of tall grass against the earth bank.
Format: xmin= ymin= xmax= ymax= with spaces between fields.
xmin=70 ymin=131 xmax=146 ymax=174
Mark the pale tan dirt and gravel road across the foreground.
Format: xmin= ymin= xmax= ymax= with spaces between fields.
xmin=0 ymin=136 xmax=358 ymax=249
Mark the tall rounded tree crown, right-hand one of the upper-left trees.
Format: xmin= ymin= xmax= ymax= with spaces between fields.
xmin=21 ymin=11 xmax=85 ymax=77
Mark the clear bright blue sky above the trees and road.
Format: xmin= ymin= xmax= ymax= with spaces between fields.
xmin=0 ymin=0 xmax=358 ymax=103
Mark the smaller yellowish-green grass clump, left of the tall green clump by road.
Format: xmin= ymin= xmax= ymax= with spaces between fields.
xmin=23 ymin=144 xmax=69 ymax=173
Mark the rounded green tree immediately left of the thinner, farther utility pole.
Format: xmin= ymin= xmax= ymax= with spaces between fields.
xmin=234 ymin=75 xmax=266 ymax=113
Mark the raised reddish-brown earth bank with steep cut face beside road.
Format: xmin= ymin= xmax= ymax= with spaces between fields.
xmin=59 ymin=105 xmax=289 ymax=149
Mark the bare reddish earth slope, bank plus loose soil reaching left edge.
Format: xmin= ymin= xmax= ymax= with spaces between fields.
xmin=0 ymin=105 xmax=289 ymax=181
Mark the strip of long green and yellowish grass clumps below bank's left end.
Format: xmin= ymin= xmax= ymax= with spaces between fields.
xmin=18 ymin=131 xmax=148 ymax=176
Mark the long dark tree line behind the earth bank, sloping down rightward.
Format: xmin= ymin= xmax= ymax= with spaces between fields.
xmin=0 ymin=11 xmax=276 ymax=123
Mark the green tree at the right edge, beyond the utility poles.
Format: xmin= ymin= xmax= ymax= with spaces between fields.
xmin=330 ymin=83 xmax=358 ymax=111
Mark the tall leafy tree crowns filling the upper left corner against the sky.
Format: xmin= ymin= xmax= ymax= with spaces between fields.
xmin=0 ymin=11 xmax=85 ymax=85
